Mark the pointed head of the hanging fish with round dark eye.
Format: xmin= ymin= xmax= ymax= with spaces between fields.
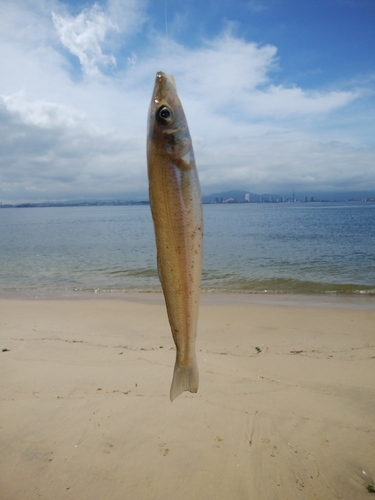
xmin=148 ymin=71 xmax=193 ymax=162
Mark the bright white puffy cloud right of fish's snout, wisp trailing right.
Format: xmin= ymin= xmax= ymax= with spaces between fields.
xmin=155 ymin=33 xmax=358 ymax=121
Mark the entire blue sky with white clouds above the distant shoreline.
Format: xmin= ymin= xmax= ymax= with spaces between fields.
xmin=0 ymin=0 xmax=375 ymax=203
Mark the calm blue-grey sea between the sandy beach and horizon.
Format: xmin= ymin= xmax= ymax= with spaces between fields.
xmin=0 ymin=202 xmax=375 ymax=297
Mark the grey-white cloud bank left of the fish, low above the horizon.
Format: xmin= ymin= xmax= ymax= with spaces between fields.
xmin=0 ymin=94 xmax=145 ymax=200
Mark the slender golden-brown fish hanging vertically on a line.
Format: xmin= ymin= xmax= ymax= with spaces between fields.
xmin=147 ymin=71 xmax=203 ymax=401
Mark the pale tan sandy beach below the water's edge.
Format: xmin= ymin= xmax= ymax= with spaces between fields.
xmin=0 ymin=294 xmax=375 ymax=500
